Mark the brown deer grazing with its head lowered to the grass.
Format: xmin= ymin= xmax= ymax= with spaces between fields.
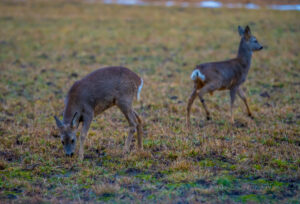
xmin=54 ymin=67 xmax=143 ymax=160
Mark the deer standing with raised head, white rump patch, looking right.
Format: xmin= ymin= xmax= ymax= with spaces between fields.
xmin=186 ymin=26 xmax=263 ymax=128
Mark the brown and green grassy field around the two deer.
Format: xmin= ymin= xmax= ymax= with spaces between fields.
xmin=0 ymin=1 xmax=300 ymax=203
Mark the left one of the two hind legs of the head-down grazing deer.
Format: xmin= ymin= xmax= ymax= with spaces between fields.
xmin=117 ymin=101 xmax=138 ymax=153
